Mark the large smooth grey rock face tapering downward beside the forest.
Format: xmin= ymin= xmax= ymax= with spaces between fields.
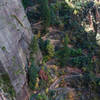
xmin=0 ymin=0 xmax=32 ymax=100
